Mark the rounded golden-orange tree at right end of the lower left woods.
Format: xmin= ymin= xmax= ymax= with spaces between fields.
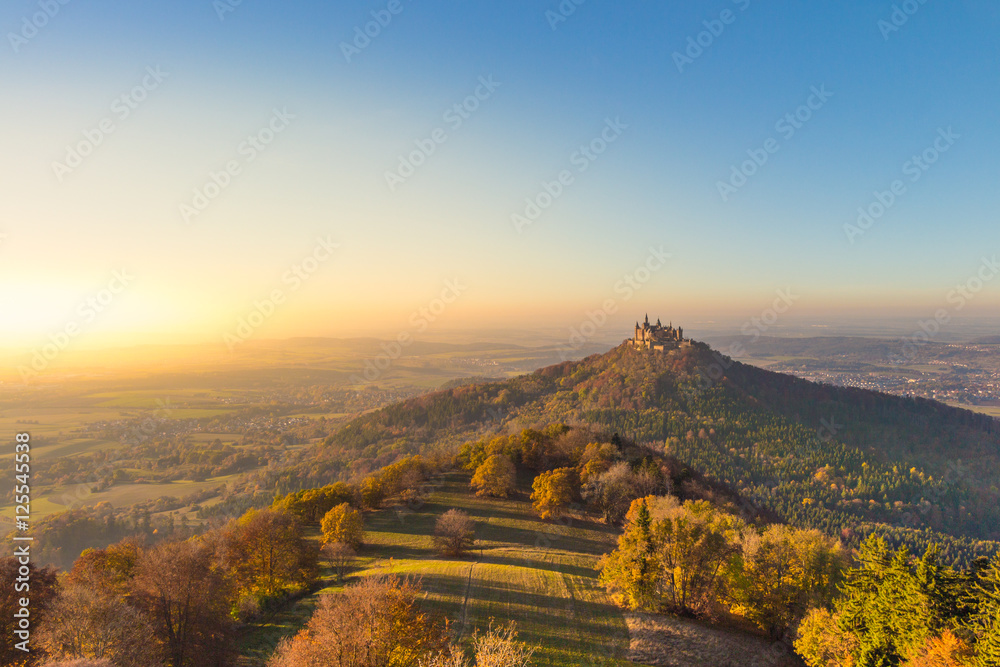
xmin=221 ymin=509 xmax=316 ymax=598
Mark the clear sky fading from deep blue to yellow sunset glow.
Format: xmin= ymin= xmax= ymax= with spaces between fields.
xmin=0 ymin=0 xmax=1000 ymax=349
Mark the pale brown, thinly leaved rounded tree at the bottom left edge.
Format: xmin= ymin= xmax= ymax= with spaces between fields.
xmin=39 ymin=577 xmax=163 ymax=667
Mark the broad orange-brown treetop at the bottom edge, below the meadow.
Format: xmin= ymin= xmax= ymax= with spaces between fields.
xmin=268 ymin=577 xmax=447 ymax=667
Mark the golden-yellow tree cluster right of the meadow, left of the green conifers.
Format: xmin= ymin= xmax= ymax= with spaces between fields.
xmin=601 ymin=496 xmax=847 ymax=639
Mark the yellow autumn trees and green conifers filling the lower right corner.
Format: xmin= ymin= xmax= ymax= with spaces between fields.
xmin=601 ymin=496 xmax=1000 ymax=667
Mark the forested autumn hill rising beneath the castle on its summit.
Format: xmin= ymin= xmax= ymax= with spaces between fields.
xmin=324 ymin=343 xmax=1000 ymax=563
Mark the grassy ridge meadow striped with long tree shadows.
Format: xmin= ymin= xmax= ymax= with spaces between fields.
xmin=241 ymin=473 xmax=636 ymax=667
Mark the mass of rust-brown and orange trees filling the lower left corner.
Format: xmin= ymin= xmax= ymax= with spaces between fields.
xmin=0 ymin=510 xmax=317 ymax=667
